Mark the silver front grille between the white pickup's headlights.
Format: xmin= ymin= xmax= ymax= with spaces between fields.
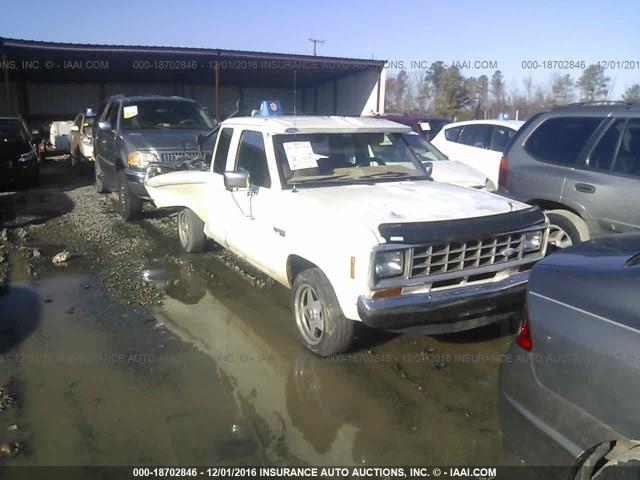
xmin=409 ymin=232 xmax=537 ymax=278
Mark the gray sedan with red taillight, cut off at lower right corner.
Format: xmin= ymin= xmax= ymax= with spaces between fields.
xmin=499 ymin=234 xmax=640 ymax=479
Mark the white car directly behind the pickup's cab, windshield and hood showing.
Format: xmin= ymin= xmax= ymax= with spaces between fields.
xmin=402 ymin=132 xmax=496 ymax=192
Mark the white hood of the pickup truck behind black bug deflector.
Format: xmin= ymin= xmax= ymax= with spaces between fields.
xmin=291 ymin=181 xmax=530 ymax=235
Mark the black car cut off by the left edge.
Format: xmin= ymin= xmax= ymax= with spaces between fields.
xmin=0 ymin=117 xmax=40 ymax=186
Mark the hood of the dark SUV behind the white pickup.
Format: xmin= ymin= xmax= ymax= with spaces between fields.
xmin=123 ymin=128 xmax=215 ymax=151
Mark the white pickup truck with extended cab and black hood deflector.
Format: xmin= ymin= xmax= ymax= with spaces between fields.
xmin=146 ymin=116 xmax=548 ymax=356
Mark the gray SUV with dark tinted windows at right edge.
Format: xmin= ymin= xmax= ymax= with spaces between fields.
xmin=499 ymin=102 xmax=640 ymax=248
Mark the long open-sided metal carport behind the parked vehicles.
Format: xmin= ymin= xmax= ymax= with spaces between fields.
xmin=0 ymin=38 xmax=385 ymax=122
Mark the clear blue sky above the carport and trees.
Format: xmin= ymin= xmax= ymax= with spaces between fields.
xmin=0 ymin=0 xmax=640 ymax=99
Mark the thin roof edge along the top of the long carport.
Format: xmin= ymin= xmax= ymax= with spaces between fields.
xmin=0 ymin=37 xmax=385 ymax=67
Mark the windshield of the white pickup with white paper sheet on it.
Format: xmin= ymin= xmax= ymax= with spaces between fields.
xmin=273 ymin=133 xmax=429 ymax=187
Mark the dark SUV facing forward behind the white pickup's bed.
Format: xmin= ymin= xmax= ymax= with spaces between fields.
xmin=94 ymin=96 xmax=213 ymax=220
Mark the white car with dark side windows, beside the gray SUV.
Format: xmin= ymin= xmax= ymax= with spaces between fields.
xmin=432 ymin=120 xmax=524 ymax=185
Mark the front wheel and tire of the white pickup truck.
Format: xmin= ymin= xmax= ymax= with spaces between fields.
xmin=291 ymin=267 xmax=354 ymax=357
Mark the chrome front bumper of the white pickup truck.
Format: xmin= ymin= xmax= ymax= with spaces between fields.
xmin=358 ymin=272 xmax=529 ymax=335
